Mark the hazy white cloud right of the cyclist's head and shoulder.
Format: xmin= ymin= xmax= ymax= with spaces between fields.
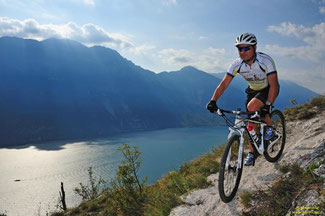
xmin=265 ymin=22 xmax=325 ymax=93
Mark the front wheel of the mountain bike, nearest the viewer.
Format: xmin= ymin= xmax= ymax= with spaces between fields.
xmin=219 ymin=135 xmax=243 ymax=203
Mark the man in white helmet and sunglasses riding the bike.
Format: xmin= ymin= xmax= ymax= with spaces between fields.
xmin=207 ymin=33 xmax=279 ymax=166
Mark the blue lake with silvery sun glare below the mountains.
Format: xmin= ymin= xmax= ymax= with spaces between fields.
xmin=0 ymin=126 xmax=228 ymax=216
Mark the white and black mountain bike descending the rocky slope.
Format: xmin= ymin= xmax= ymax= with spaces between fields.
xmin=215 ymin=109 xmax=286 ymax=203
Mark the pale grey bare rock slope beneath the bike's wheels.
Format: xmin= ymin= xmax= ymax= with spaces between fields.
xmin=170 ymin=111 xmax=325 ymax=216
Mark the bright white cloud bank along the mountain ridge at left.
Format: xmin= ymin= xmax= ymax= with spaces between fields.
xmin=0 ymin=17 xmax=134 ymax=49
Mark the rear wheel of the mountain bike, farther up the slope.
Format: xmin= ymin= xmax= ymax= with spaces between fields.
xmin=264 ymin=110 xmax=286 ymax=162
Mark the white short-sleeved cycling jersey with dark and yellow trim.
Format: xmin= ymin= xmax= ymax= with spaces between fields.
xmin=227 ymin=52 xmax=276 ymax=91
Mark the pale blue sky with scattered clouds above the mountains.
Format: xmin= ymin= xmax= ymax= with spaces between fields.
xmin=0 ymin=0 xmax=325 ymax=94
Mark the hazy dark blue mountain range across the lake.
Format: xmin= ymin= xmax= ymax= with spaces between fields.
xmin=0 ymin=37 xmax=314 ymax=146
